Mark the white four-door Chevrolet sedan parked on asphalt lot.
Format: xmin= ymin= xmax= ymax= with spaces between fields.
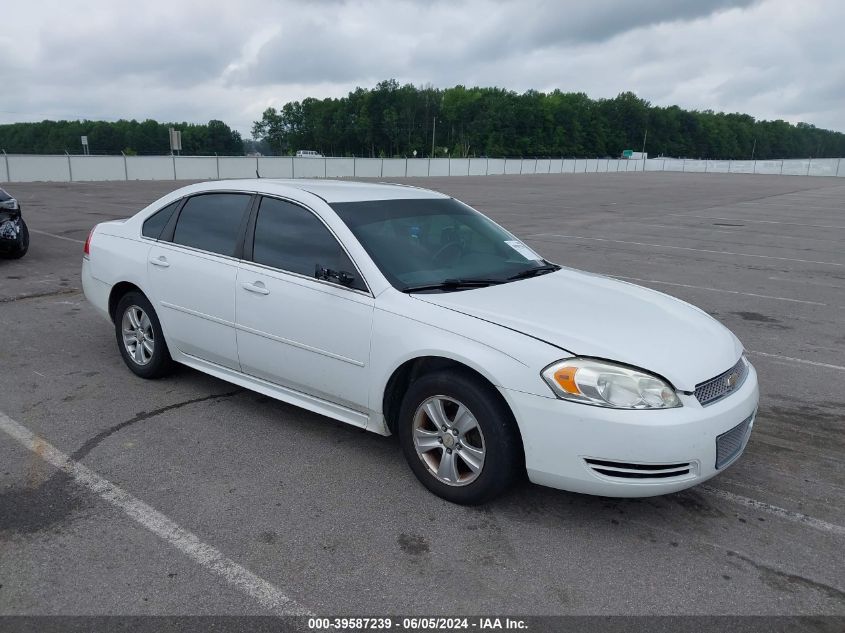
xmin=82 ymin=180 xmax=758 ymax=503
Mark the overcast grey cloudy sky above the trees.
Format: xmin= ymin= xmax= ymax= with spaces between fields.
xmin=0 ymin=0 xmax=845 ymax=137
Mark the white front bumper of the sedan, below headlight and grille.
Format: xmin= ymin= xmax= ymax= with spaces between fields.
xmin=501 ymin=366 xmax=759 ymax=497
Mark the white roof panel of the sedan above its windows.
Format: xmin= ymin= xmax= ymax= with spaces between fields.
xmin=187 ymin=178 xmax=449 ymax=203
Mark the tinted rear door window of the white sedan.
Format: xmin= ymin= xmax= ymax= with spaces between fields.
xmin=173 ymin=193 xmax=250 ymax=257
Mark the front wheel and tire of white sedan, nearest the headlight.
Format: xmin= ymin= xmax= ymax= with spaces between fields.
xmin=397 ymin=370 xmax=522 ymax=505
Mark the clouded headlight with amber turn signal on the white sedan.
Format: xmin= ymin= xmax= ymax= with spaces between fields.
xmin=542 ymin=358 xmax=681 ymax=409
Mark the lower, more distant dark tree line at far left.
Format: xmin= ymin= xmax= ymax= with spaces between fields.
xmin=0 ymin=119 xmax=244 ymax=156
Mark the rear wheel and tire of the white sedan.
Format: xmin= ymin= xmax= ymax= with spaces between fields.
xmin=114 ymin=291 xmax=173 ymax=379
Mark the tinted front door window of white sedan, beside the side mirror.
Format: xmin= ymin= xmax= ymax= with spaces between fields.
xmin=253 ymin=198 xmax=367 ymax=290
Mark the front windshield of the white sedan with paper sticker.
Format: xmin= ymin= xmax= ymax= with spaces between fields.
xmin=331 ymin=198 xmax=557 ymax=291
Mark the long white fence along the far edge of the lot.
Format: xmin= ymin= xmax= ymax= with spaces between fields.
xmin=0 ymin=153 xmax=845 ymax=182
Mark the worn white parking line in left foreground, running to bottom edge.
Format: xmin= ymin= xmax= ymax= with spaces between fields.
xmin=0 ymin=411 xmax=310 ymax=615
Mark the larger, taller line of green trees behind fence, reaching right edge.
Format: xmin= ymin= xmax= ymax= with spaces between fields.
xmin=252 ymin=79 xmax=845 ymax=159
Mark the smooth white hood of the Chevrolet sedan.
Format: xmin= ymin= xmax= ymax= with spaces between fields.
xmin=413 ymin=268 xmax=742 ymax=391
